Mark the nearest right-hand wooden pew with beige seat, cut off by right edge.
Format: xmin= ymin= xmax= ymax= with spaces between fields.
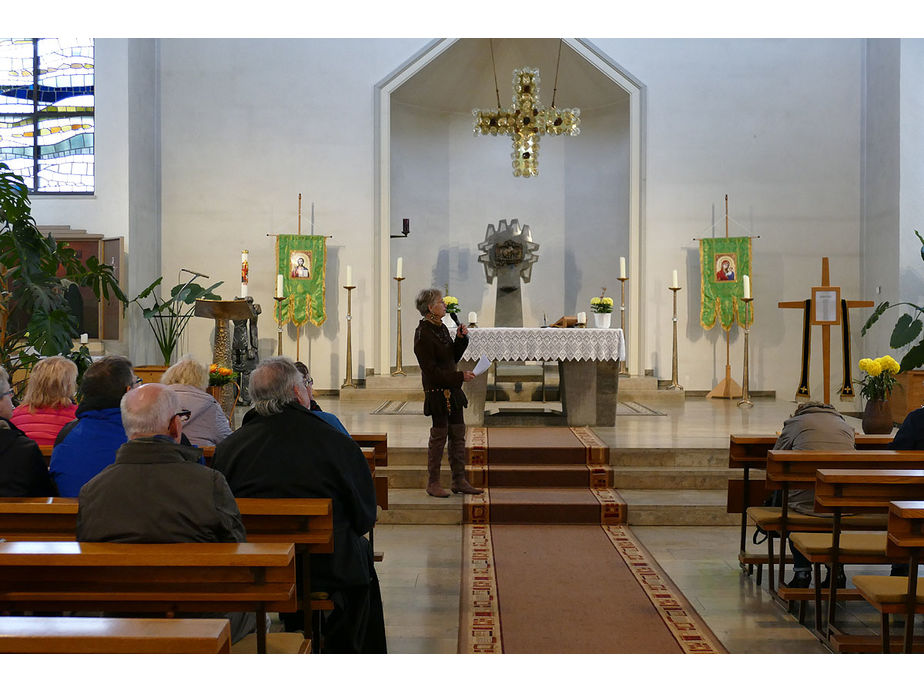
xmin=853 ymin=501 xmax=924 ymax=654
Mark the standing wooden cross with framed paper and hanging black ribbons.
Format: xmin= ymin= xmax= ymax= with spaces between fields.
xmin=777 ymin=257 xmax=875 ymax=404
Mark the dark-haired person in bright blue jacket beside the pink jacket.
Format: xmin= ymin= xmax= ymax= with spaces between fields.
xmin=49 ymin=356 xmax=135 ymax=498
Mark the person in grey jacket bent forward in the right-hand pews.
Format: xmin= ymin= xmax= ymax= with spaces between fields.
xmin=773 ymin=401 xmax=856 ymax=587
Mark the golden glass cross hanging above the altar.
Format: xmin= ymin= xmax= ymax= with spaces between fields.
xmin=473 ymin=67 xmax=581 ymax=178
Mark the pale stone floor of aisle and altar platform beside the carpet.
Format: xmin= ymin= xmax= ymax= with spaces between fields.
xmin=272 ymin=397 xmax=908 ymax=654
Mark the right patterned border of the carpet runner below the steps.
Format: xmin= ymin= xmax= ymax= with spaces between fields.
xmin=603 ymin=525 xmax=728 ymax=654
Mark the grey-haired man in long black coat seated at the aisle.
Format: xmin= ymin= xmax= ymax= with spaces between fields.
xmin=214 ymin=356 xmax=386 ymax=653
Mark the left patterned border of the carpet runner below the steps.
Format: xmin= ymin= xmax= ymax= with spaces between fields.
xmin=459 ymin=524 xmax=504 ymax=654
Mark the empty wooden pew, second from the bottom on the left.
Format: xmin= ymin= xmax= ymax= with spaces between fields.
xmin=0 ymin=541 xmax=297 ymax=653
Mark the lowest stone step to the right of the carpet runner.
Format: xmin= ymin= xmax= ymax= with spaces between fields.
xmin=619 ymin=489 xmax=741 ymax=526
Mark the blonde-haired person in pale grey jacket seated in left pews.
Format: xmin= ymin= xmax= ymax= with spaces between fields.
xmin=160 ymin=356 xmax=231 ymax=448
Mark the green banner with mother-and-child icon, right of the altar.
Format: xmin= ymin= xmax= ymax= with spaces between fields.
xmin=699 ymin=236 xmax=754 ymax=330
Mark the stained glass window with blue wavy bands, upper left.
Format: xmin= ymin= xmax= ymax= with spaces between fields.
xmin=0 ymin=38 xmax=94 ymax=193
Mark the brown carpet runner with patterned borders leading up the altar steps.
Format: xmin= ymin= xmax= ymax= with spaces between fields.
xmin=459 ymin=427 xmax=725 ymax=654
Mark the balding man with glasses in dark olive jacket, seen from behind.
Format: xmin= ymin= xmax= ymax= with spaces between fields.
xmin=77 ymin=383 xmax=256 ymax=642
